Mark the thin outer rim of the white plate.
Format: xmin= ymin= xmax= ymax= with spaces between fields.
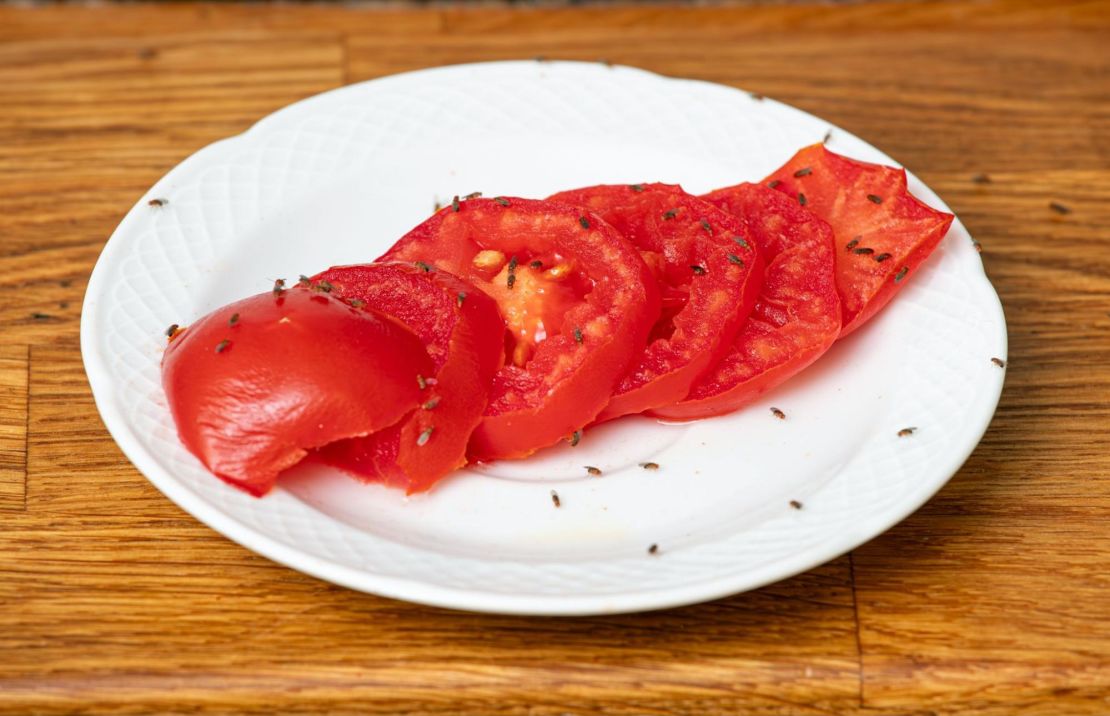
xmin=80 ymin=60 xmax=1008 ymax=616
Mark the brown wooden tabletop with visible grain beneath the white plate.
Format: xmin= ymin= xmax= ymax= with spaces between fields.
xmin=0 ymin=0 xmax=1110 ymax=716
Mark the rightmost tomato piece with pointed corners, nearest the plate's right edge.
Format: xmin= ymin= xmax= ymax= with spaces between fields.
xmin=765 ymin=144 xmax=955 ymax=335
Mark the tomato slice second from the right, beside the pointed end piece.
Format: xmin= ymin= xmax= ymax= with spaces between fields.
xmin=652 ymin=184 xmax=840 ymax=420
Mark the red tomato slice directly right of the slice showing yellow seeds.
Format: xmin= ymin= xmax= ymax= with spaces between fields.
xmin=548 ymin=184 xmax=763 ymax=421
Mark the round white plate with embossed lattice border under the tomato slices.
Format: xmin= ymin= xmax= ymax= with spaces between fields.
xmin=81 ymin=61 xmax=1006 ymax=614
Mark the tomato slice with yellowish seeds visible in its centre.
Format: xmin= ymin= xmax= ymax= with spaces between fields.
xmin=382 ymin=196 xmax=659 ymax=460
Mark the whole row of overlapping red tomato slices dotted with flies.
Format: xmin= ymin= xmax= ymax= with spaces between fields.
xmin=162 ymin=144 xmax=952 ymax=495
